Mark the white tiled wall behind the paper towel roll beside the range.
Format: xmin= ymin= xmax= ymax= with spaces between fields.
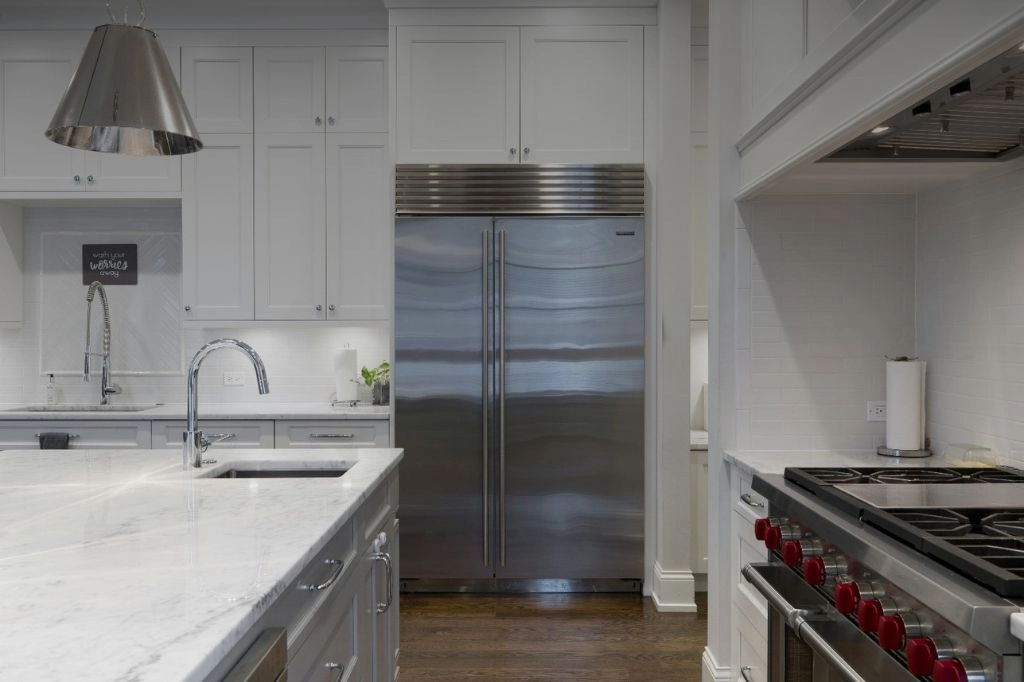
xmin=735 ymin=197 xmax=914 ymax=450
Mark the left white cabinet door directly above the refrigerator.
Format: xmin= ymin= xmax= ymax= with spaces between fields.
xmin=396 ymin=27 xmax=519 ymax=163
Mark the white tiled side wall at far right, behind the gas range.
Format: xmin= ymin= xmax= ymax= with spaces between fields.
xmin=918 ymin=161 xmax=1024 ymax=464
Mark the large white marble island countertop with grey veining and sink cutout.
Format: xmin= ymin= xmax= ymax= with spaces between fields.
xmin=0 ymin=449 xmax=401 ymax=681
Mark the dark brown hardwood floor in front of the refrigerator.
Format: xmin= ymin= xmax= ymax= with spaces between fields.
xmin=400 ymin=594 xmax=708 ymax=682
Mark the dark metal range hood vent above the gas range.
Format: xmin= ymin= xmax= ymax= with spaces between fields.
xmin=822 ymin=47 xmax=1024 ymax=162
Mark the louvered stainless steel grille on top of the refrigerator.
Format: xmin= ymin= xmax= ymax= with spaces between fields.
xmin=394 ymin=164 xmax=644 ymax=215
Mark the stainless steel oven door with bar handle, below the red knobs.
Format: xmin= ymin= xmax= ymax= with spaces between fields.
xmin=742 ymin=563 xmax=918 ymax=682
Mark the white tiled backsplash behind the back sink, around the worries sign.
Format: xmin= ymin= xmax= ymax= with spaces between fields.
xmin=0 ymin=207 xmax=390 ymax=404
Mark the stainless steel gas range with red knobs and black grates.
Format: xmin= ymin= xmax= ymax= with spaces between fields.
xmin=743 ymin=467 xmax=1024 ymax=682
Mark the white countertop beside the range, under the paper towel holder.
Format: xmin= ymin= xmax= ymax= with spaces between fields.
xmin=724 ymin=450 xmax=974 ymax=474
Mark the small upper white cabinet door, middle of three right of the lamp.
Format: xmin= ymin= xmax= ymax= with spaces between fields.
xmin=253 ymin=47 xmax=326 ymax=132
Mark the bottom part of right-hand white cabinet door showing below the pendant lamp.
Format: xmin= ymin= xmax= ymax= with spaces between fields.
xmin=82 ymin=152 xmax=182 ymax=193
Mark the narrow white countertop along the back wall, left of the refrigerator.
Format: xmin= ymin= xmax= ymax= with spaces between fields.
xmin=0 ymin=398 xmax=391 ymax=421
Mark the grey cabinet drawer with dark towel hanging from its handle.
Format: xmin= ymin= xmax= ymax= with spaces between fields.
xmin=0 ymin=420 xmax=151 ymax=450
